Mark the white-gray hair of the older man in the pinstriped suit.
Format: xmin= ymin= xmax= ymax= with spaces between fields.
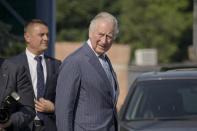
xmin=89 ymin=12 xmax=119 ymax=40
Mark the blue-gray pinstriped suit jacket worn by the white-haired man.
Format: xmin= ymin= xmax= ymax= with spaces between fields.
xmin=55 ymin=44 xmax=119 ymax=131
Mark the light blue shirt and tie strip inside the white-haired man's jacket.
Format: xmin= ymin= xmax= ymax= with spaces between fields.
xmin=99 ymin=55 xmax=114 ymax=95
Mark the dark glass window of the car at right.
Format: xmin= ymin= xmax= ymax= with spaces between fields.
xmin=125 ymin=79 xmax=197 ymax=120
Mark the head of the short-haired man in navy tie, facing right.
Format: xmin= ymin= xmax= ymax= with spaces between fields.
xmin=24 ymin=23 xmax=49 ymax=55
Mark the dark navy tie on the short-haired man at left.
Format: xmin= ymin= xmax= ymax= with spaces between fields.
xmin=35 ymin=56 xmax=44 ymax=120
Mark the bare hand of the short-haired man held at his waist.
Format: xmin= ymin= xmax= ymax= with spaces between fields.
xmin=34 ymin=98 xmax=55 ymax=113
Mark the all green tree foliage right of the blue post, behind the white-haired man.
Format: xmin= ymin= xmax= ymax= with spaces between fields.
xmin=57 ymin=0 xmax=193 ymax=63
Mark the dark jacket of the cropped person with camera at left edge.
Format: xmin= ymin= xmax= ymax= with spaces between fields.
xmin=0 ymin=58 xmax=35 ymax=131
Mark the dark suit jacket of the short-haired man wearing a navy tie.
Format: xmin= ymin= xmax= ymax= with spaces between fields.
xmin=10 ymin=52 xmax=61 ymax=131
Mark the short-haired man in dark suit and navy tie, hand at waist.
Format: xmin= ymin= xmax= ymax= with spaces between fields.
xmin=10 ymin=19 xmax=61 ymax=131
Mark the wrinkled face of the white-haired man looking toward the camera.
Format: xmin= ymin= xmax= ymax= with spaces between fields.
xmin=89 ymin=19 xmax=114 ymax=55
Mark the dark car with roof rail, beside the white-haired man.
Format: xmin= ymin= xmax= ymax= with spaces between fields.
xmin=119 ymin=67 xmax=197 ymax=131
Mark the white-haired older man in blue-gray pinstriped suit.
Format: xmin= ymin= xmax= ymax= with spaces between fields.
xmin=55 ymin=12 xmax=119 ymax=131
